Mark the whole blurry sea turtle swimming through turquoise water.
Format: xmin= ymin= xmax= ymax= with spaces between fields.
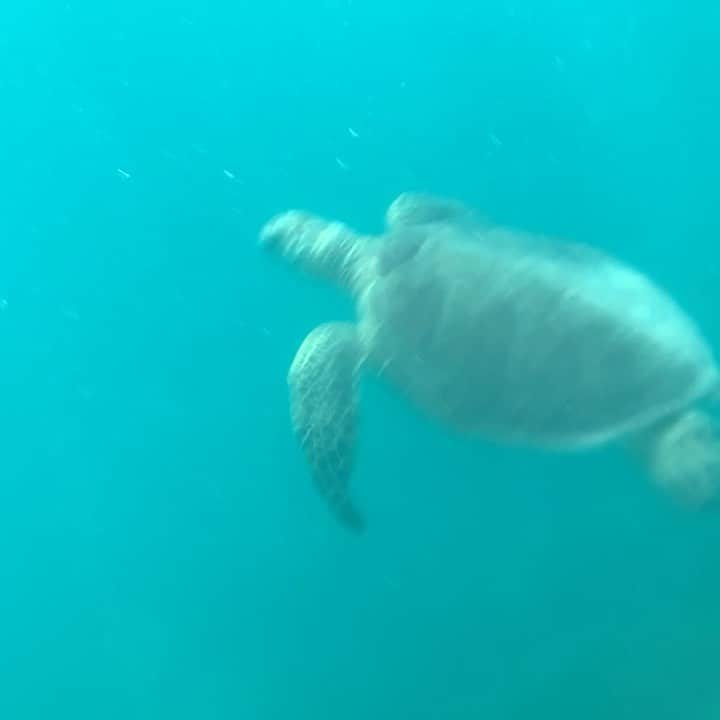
xmin=260 ymin=192 xmax=720 ymax=531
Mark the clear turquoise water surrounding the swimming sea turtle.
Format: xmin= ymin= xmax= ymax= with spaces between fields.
xmin=0 ymin=0 xmax=720 ymax=720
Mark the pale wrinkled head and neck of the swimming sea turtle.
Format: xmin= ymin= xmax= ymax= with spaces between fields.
xmin=260 ymin=210 xmax=368 ymax=293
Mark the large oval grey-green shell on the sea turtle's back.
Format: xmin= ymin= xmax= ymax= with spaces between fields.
xmin=359 ymin=200 xmax=718 ymax=448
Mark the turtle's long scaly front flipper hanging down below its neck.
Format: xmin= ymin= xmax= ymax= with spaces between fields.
xmin=288 ymin=323 xmax=365 ymax=532
